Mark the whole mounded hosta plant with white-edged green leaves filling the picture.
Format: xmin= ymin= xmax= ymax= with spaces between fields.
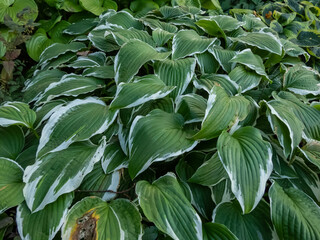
xmin=0 ymin=1 xmax=320 ymax=240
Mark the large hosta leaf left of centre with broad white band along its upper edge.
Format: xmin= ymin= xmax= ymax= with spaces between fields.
xmin=37 ymin=97 xmax=117 ymax=157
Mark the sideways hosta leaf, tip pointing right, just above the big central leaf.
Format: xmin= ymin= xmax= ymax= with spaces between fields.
xmin=110 ymin=75 xmax=175 ymax=109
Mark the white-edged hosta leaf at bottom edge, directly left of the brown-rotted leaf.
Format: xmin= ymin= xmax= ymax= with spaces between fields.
xmin=16 ymin=194 xmax=73 ymax=240
